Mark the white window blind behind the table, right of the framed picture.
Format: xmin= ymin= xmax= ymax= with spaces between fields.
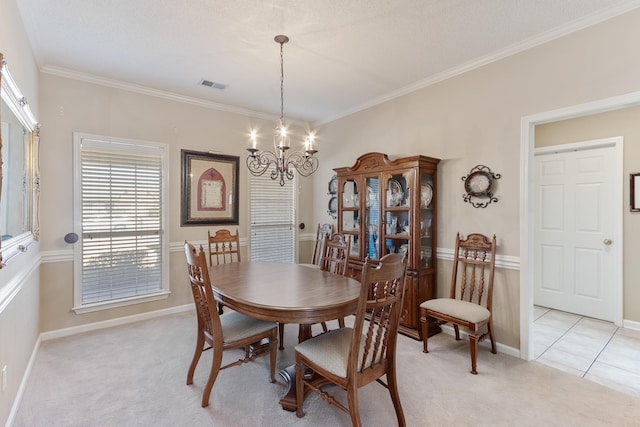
xmin=249 ymin=174 xmax=297 ymax=262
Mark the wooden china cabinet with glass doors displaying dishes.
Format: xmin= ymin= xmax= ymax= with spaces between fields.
xmin=334 ymin=153 xmax=440 ymax=339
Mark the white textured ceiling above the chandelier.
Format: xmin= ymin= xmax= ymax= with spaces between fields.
xmin=16 ymin=0 xmax=640 ymax=122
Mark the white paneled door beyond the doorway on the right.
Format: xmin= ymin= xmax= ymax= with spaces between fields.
xmin=534 ymin=140 xmax=622 ymax=321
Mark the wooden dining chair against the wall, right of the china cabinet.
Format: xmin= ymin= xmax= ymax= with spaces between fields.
xmin=420 ymin=233 xmax=496 ymax=374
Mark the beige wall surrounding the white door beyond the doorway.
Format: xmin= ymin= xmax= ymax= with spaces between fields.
xmin=535 ymin=107 xmax=640 ymax=322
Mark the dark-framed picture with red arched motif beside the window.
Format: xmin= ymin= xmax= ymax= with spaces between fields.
xmin=181 ymin=150 xmax=240 ymax=225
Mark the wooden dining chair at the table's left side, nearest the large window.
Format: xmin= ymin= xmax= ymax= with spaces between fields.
xmin=184 ymin=242 xmax=278 ymax=408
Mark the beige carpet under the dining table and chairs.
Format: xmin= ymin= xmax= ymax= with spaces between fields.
xmin=14 ymin=312 xmax=640 ymax=427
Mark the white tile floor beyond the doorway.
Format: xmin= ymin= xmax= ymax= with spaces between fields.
xmin=533 ymin=306 xmax=640 ymax=397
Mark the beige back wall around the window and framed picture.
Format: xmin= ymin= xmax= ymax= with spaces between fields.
xmin=40 ymin=74 xmax=313 ymax=332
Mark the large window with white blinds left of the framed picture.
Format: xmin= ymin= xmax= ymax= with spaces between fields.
xmin=73 ymin=133 xmax=169 ymax=313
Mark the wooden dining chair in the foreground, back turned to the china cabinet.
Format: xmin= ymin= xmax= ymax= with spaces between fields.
xmin=295 ymin=254 xmax=406 ymax=426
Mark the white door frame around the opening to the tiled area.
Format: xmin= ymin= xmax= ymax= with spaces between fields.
xmin=520 ymin=92 xmax=640 ymax=360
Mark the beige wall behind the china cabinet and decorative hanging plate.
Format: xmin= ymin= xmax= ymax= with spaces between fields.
xmin=315 ymin=7 xmax=640 ymax=348
